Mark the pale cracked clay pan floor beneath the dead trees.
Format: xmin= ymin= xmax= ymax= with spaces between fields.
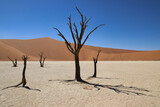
xmin=0 ymin=61 xmax=160 ymax=107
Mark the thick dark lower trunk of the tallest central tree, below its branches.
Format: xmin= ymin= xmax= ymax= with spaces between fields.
xmin=75 ymin=55 xmax=82 ymax=81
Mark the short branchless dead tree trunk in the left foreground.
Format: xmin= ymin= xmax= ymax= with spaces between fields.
xmin=15 ymin=56 xmax=28 ymax=87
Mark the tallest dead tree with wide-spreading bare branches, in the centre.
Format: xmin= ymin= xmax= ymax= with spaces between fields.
xmin=54 ymin=7 xmax=104 ymax=82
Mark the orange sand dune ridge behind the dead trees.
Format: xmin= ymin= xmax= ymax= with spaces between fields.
xmin=0 ymin=37 xmax=160 ymax=61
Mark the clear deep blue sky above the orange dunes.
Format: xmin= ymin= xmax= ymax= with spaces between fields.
xmin=0 ymin=0 xmax=160 ymax=50
